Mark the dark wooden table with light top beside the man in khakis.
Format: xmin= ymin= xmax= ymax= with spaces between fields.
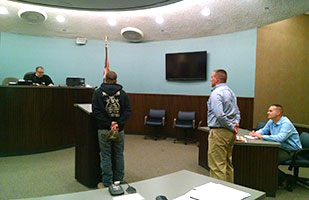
xmin=198 ymin=127 xmax=280 ymax=197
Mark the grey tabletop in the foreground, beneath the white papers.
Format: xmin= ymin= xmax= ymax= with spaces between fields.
xmin=19 ymin=170 xmax=265 ymax=200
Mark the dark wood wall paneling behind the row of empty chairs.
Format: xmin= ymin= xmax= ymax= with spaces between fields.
xmin=125 ymin=93 xmax=253 ymax=137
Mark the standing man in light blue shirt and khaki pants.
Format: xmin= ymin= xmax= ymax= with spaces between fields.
xmin=207 ymin=69 xmax=240 ymax=183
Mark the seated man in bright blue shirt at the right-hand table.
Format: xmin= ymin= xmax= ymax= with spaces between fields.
xmin=250 ymin=104 xmax=302 ymax=189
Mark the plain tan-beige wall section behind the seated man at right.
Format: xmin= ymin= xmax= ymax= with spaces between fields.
xmin=253 ymin=15 xmax=309 ymax=126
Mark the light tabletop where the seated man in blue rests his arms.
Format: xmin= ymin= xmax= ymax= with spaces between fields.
xmin=198 ymin=126 xmax=281 ymax=147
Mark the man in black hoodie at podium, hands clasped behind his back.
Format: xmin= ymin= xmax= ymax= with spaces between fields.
xmin=92 ymin=71 xmax=131 ymax=188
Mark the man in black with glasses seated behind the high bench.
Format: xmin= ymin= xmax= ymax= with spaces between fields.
xmin=24 ymin=66 xmax=54 ymax=86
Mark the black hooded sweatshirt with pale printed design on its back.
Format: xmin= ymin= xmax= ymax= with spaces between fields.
xmin=92 ymin=83 xmax=131 ymax=131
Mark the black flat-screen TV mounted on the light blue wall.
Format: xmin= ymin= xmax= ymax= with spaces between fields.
xmin=165 ymin=51 xmax=207 ymax=81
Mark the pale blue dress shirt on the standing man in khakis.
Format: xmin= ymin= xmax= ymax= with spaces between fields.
xmin=207 ymin=83 xmax=240 ymax=131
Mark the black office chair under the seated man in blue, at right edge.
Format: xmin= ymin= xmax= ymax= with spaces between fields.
xmin=283 ymin=132 xmax=309 ymax=190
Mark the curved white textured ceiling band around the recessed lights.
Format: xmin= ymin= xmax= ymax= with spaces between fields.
xmin=0 ymin=0 xmax=309 ymax=41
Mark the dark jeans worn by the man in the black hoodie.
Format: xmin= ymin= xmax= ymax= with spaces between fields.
xmin=98 ymin=129 xmax=124 ymax=187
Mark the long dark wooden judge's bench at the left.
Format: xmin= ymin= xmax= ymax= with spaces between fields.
xmin=0 ymin=85 xmax=94 ymax=156
